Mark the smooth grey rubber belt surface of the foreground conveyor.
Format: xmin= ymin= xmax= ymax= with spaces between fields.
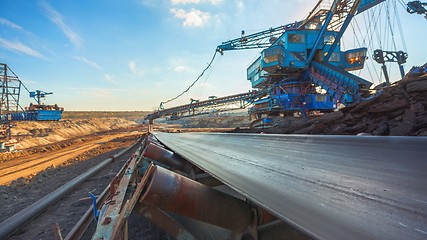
xmin=156 ymin=133 xmax=427 ymax=239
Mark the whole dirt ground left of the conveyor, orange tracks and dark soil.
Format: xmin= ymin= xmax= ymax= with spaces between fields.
xmin=0 ymin=116 xmax=174 ymax=239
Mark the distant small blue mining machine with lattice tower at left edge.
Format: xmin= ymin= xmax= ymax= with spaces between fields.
xmin=0 ymin=63 xmax=64 ymax=143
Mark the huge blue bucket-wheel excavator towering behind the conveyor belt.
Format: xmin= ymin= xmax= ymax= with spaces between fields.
xmin=147 ymin=0 xmax=412 ymax=126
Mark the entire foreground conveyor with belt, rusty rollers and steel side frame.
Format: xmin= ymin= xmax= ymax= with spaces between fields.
xmin=92 ymin=133 xmax=427 ymax=240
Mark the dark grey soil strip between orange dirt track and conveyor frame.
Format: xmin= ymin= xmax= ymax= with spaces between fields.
xmin=0 ymin=135 xmax=168 ymax=239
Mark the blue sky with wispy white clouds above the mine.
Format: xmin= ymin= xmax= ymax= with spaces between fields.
xmin=0 ymin=0 xmax=427 ymax=111
